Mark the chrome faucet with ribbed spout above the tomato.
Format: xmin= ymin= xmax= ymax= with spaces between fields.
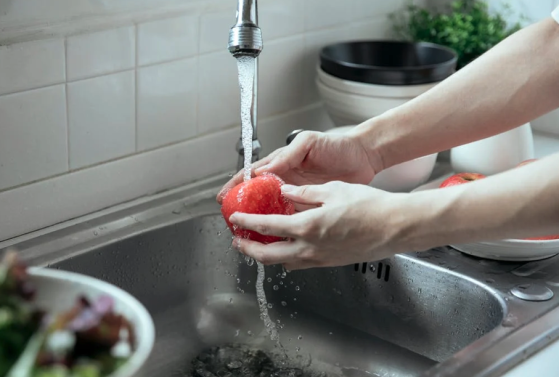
xmin=228 ymin=0 xmax=263 ymax=170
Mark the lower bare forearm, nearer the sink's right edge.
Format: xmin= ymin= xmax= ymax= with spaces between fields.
xmin=395 ymin=154 xmax=559 ymax=250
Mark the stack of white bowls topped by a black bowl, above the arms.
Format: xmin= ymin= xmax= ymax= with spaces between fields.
xmin=316 ymin=41 xmax=456 ymax=126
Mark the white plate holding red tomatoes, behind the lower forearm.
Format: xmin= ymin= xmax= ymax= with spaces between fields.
xmin=413 ymin=174 xmax=559 ymax=262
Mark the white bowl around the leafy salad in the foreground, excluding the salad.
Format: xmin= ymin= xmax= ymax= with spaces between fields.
xmin=29 ymin=268 xmax=155 ymax=377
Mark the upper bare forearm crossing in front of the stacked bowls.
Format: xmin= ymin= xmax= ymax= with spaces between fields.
xmin=353 ymin=18 xmax=559 ymax=169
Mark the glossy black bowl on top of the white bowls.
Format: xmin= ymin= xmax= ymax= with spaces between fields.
xmin=320 ymin=41 xmax=458 ymax=85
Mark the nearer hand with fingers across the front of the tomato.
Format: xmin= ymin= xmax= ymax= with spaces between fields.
xmin=230 ymin=182 xmax=405 ymax=270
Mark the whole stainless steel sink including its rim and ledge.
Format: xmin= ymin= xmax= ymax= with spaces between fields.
xmin=6 ymin=173 xmax=559 ymax=377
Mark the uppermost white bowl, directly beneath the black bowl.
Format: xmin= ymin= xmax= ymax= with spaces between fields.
xmin=316 ymin=65 xmax=438 ymax=100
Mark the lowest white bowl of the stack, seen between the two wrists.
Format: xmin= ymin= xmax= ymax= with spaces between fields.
xmin=326 ymin=126 xmax=438 ymax=192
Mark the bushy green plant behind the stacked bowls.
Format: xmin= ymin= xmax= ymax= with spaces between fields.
xmin=390 ymin=0 xmax=521 ymax=69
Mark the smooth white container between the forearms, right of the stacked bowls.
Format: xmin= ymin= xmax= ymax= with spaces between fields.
xmin=450 ymin=123 xmax=534 ymax=175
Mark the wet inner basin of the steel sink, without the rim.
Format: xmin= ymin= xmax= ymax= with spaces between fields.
xmin=47 ymin=215 xmax=504 ymax=376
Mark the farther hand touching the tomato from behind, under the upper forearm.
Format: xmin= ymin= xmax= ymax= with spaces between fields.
xmin=217 ymin=131 xmax=380 ymax=203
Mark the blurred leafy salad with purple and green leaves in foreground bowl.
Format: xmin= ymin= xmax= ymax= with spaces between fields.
xmin=0 ymin=253 xmax=136 ymax=377
